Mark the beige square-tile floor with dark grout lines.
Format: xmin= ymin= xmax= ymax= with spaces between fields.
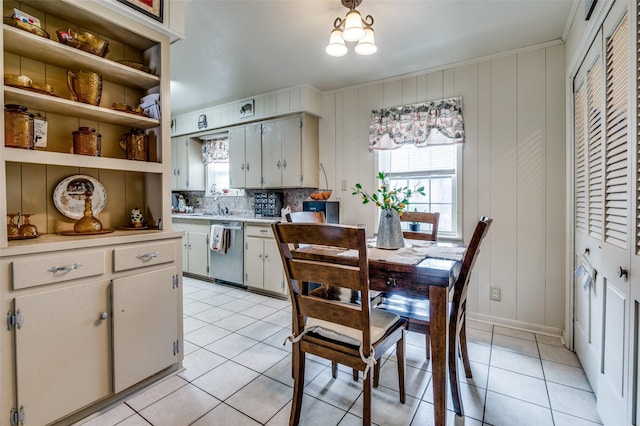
xmin=80 ymin=277 xmax=601 ymax=426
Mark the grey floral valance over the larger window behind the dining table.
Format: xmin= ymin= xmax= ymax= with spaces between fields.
xmin=369 ymin=97 xmax=464 ymax=151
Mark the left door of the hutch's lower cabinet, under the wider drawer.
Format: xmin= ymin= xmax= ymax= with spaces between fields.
xmin=14 ymin=280 xmax=111 ymax=425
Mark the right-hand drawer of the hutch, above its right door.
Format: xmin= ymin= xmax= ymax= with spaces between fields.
xmin=113 ymin=242 xmax=176 ymax=271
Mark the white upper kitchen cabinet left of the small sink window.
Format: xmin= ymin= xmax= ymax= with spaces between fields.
xmin=171 ymin=136 xmax=205 ymax=191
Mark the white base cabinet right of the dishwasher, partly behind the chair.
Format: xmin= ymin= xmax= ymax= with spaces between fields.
xmin=244 ymin=224 xmax=287 ymax=295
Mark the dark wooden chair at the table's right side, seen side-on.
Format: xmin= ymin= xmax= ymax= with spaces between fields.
xmin=375 ymin=216 xmax=493 ymax=416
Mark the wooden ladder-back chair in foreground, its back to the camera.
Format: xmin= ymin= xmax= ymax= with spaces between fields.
xmin=272 ymin=222 xmax=406 ymax=425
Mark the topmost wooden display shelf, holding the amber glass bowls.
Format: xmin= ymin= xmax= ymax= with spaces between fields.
xmin=3 ymin=24 xmax=160 ymax=90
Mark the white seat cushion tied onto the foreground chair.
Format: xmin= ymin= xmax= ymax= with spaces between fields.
xmin=305 ymin=308 xmax=400 ymax=346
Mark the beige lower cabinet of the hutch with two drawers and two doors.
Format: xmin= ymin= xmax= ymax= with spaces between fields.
xmin=0 ymin=233 xmax=183 ymax=426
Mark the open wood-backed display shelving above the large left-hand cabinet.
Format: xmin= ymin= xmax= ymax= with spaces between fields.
xmin=0 ymin=0 xmax=171 ymax=247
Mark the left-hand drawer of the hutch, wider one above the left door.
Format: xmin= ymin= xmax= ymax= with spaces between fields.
xmin=12 ymin=250 xmax=105 ymax=290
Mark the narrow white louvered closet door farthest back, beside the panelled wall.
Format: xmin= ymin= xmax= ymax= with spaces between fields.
xmin=573 ymin=32 xmax=605 ymax=388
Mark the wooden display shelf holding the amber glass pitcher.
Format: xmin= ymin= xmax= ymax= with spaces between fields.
xmin=4 ymin=86 xmax=160 ymax=130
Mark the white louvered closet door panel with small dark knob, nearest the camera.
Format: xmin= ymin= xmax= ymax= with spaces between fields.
xmin=597 ymin=2 xmax=635 ymax=425
